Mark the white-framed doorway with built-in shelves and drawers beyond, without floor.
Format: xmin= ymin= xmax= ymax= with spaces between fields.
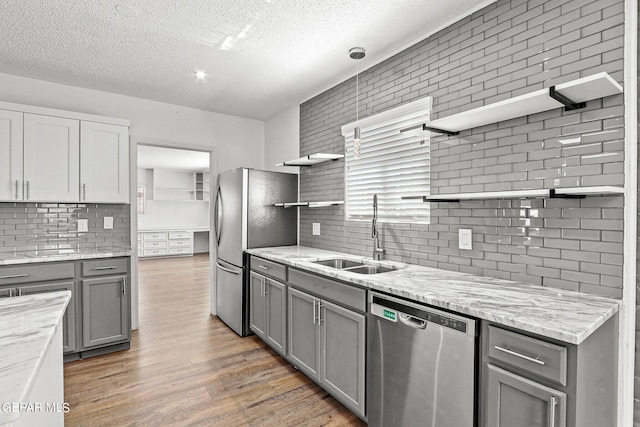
xmin=130 ymin=137 xmax=217 ymax=329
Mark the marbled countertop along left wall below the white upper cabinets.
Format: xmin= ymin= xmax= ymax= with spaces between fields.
xmin=0 ymin=247 xmax=131 ymax=265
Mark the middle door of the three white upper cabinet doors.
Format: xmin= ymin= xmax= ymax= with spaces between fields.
xmin=23 ymin=113 xmax=80 ymax=202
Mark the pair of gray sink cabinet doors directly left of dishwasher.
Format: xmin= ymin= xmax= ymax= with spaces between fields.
xmin=288 ymin=287 xmax=366 ymax=417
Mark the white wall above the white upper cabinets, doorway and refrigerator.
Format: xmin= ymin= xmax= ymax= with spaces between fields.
xmin=0 ymin=73 xmax=264 ymax=172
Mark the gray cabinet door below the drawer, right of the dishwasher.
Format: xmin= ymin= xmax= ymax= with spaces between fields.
xmin=485 ymin=365 xmax=567 ymax=427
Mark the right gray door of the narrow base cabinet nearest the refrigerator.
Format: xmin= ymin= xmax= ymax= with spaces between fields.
xmin=265 ymin=279 xmax=287 ymax=356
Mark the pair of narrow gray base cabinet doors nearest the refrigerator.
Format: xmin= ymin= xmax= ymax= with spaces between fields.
xmin=249 ymin=271 xmax=287 ymax=356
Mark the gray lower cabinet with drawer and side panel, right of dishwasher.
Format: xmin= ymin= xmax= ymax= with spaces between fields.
xmin=480 ymin=315 xmax=618 ymax=427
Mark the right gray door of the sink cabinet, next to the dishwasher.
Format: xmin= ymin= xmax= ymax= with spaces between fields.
xmin=319 ymin=300 xmax=366 ymax=416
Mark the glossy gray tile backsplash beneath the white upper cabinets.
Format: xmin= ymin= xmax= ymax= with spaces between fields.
xmin=0 ymin=203 xmax=131 ymax=252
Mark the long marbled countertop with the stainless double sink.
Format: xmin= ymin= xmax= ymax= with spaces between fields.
xmin=247 ymin=246 xmax=622 ymax=344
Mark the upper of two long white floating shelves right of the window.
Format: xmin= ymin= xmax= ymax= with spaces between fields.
xmin=401 ymin=72 xmax=622 ymax=135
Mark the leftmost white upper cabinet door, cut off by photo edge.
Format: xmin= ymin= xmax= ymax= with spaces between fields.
xmin=0 ymin=110 xmax=23 ymax=201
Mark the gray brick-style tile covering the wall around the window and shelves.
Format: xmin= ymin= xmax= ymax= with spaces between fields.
xmin=300 ymin=0 xmax=624 ymax=297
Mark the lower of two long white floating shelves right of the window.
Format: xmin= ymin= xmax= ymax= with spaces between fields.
xmin=402 ymin=186 xmax=624 ymax=202
